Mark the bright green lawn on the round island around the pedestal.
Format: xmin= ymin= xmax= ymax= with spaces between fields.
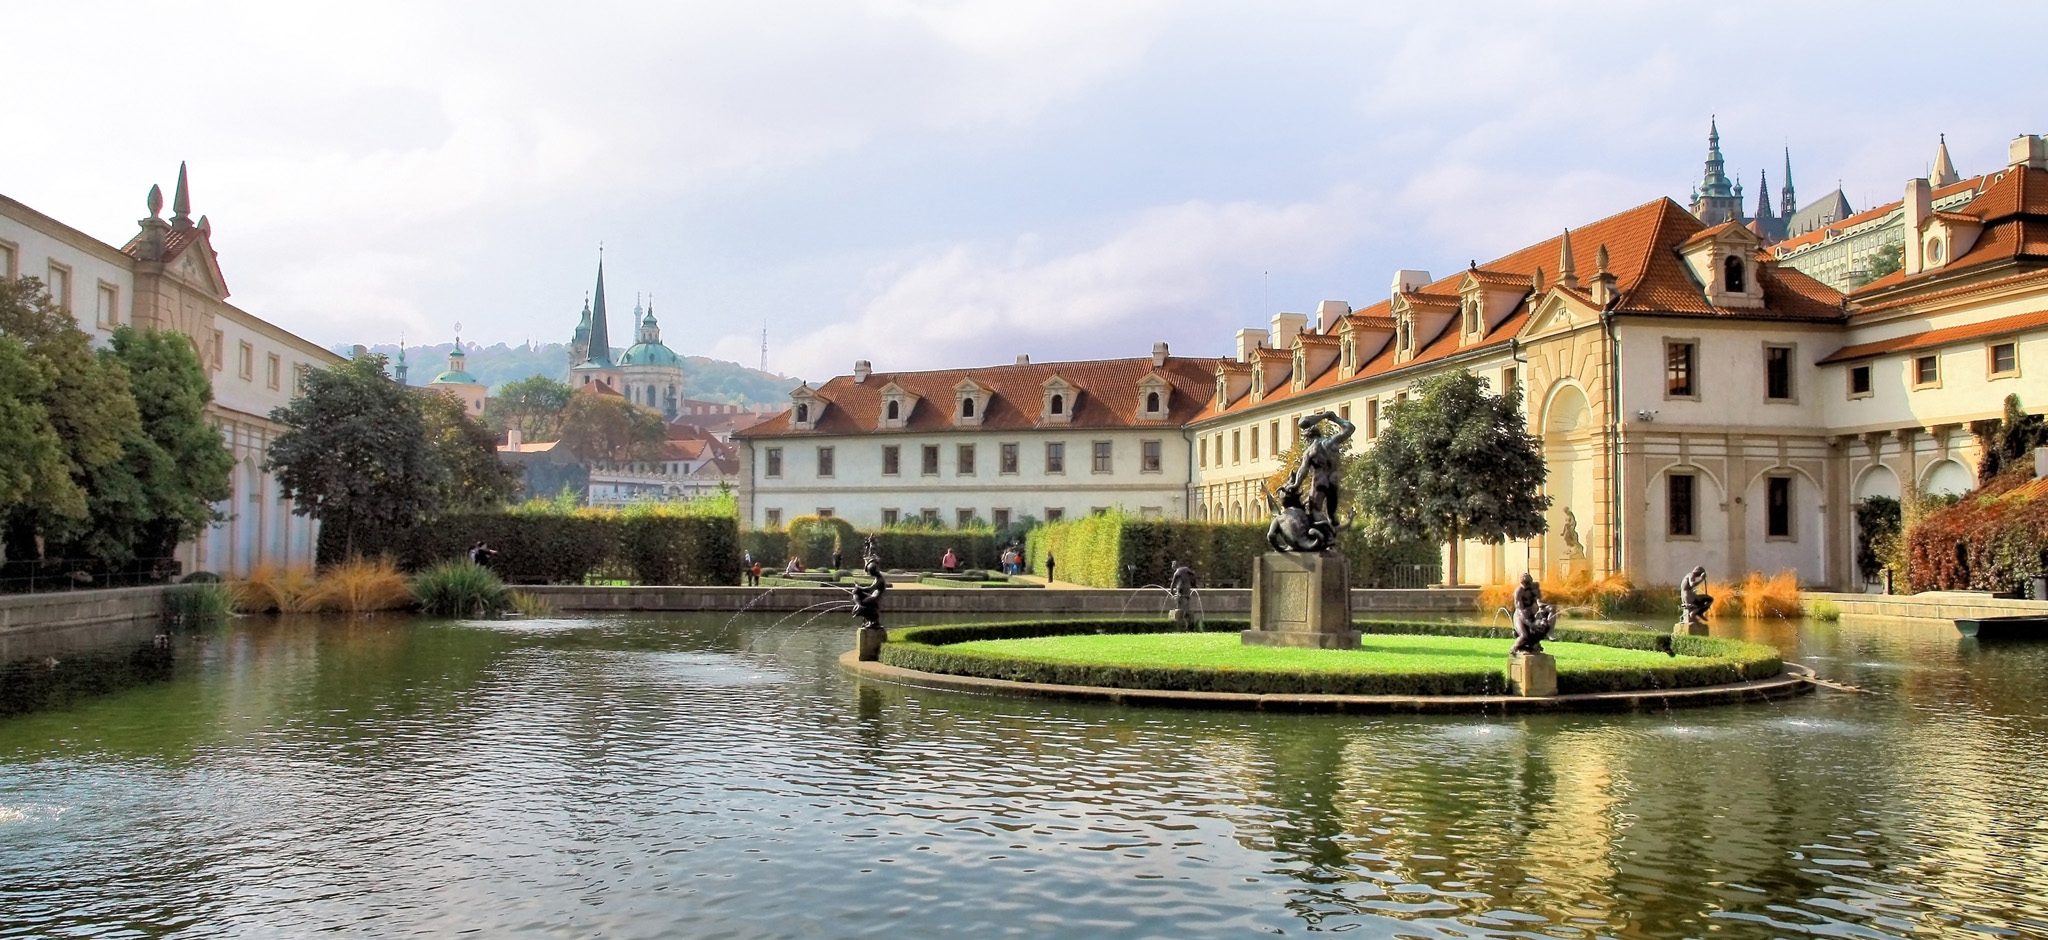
xmin=944 ymin=633 xmax=1671 ymax=674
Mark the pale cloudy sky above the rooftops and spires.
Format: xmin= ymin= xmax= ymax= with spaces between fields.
xmin=0 ymin=0 xmax=2048 ymax=379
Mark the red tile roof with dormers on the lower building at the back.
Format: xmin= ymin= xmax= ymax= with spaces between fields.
xmin=733 ymin=356 xmax=1219 ymax=438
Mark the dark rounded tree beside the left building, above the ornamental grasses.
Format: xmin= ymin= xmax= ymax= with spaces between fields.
xmin=264 ymin=354 xmax=444 ymax=555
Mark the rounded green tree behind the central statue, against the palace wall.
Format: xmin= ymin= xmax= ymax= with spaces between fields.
xmin=1350 ymin=371 xmax=1550 ymax=584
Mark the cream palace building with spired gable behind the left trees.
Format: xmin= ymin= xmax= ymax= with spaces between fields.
xmin=0 ymin=166 xmax=340 ymax=575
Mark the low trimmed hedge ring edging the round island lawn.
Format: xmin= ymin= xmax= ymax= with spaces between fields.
xmin=881 ymin=618 xmax=1784 ymax=696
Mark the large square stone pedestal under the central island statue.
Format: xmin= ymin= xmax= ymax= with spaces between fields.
xmin=1243 ymin=551 xmax=1358 ymax=649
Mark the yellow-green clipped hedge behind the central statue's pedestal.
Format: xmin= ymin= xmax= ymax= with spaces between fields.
xmin=1026 ymin=512 xmax=1440 ymax=588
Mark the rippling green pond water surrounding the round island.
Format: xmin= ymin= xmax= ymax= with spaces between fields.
xmin=0 ymin=614 xmax=2048 ymax=940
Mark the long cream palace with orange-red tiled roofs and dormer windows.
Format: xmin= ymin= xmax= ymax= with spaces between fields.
xmin=735 ymin=135 xmax=2048 ymax=590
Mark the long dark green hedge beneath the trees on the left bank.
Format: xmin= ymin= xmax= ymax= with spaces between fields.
xmin=319 ymin=512 xmax=739 ymax=584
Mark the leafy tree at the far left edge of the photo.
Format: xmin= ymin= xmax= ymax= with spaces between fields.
xmin=0 ymin=279 xmax=141 ymax=561
